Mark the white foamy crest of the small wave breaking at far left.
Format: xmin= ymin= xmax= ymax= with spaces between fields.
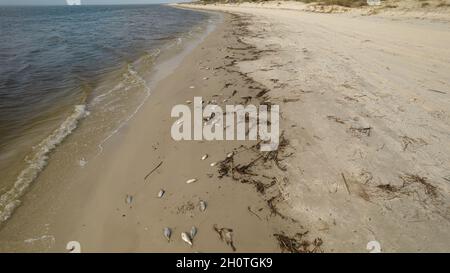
xmin=0 ymin=105 xmax=89 ymax=223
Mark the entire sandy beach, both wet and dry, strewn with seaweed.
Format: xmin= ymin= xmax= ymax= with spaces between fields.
xmin=0 ymin=2 xmax=450 ymax=252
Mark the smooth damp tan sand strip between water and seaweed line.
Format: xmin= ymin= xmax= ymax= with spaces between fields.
xmin=0 ymin=9 xmax=288 ymax=252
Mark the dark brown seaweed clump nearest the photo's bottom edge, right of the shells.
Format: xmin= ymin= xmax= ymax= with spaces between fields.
xmin=273 ymin=231 xmax=323 ymax=253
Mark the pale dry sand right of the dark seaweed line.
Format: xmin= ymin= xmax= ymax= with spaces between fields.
xmin=176 ymin=3 xmax=450 ymax=252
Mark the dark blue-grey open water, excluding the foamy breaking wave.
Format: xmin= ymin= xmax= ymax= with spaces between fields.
xmin=0 ymin=5 xmax=204 ymax=146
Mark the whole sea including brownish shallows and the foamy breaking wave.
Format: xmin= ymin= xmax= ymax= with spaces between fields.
xmin=0 ymin=5 xmax=208 ymax=222
